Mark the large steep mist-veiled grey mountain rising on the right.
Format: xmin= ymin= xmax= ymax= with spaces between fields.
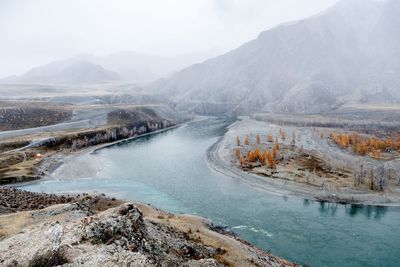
xmin=151 ymin=0 xmax=400 ymax=112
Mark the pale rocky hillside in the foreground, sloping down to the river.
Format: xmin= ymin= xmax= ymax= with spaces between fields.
xmin=0 ymin=189 xmax=296 ymax=266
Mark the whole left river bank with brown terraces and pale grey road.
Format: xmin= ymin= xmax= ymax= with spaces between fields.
xmin=0 ymin=100 xmax=186 ymax=185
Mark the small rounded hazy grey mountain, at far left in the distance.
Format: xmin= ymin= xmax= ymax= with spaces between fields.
xmin=3 ymin=60 xmax=122 ymax=84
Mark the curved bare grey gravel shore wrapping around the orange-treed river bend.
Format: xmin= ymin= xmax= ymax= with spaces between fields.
xmin=207 ymin=118 xmax=400 ymax=206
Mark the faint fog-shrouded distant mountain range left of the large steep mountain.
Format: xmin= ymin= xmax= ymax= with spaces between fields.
xmin=0 ymin=51 xmax=216 ymax=84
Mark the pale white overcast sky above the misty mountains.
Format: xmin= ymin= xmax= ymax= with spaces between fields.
xmin=0 ymin=0 xmax=337 ymax=77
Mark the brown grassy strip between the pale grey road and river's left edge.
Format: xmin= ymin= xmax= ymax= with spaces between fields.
xmin=0 ymin=124 xmax=181 ymax=185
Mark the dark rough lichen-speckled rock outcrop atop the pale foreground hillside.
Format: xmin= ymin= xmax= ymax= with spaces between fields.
xmin=76 ymin=203 xmax=220 ymax=265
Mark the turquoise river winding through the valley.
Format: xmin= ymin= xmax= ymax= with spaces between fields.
xmin=20 ymin=118 xmax=400 ymax=267
